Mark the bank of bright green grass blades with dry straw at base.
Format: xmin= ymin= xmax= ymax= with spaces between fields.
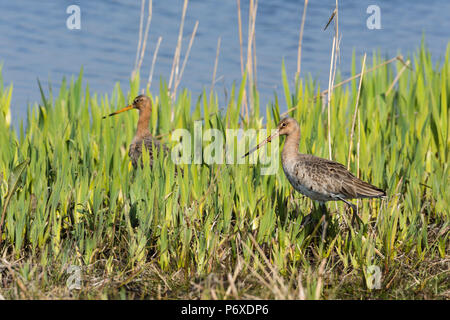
xmin=0 ymin=47 xmax=450 ymax=299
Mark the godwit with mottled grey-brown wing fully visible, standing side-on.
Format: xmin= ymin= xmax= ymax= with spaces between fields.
xmin=244 ymin=117 xmax=386 ymax=225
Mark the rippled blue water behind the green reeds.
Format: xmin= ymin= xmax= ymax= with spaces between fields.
xmin=0 ymin=0 xmax=450 ymax=124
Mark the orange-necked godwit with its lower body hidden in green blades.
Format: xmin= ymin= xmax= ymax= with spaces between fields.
xmin=103 ymin=95 xmax=168 ymax=168
